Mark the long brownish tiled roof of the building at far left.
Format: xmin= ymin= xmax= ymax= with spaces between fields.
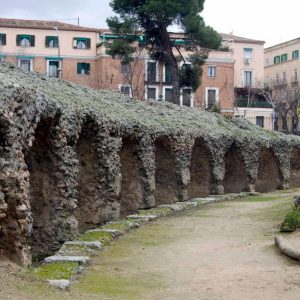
xmin=0 ymin=18 xmax=104 ymax=32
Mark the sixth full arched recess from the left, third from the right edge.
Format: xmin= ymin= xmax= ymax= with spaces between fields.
xmin=223 ymin=144 xmax=248 ymax=193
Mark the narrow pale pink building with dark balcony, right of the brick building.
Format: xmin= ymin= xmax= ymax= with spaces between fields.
xmin=221 ymin=33 xmax=274 ymax=130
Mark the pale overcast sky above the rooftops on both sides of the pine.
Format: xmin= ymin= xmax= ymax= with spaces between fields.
xmin=0 ymin=0 xmax=300 ymax=46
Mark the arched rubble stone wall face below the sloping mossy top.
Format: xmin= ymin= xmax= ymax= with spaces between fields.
xmin=0 ymin=81 xmax=300 ymax=266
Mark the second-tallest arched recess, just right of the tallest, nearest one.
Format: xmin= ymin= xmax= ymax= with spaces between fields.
xmin=75 ymin=121 xmax=105 ymax=232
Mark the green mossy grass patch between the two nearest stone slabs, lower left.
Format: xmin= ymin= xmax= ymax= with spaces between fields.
xmin=31 ymin=262 xmax=78 ymax=280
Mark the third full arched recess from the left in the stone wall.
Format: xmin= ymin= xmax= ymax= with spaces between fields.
xmin=119 ymin=138 xmax=145 ymax=216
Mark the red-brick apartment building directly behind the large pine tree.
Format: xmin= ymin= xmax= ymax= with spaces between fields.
xmin=97 ymin=32 xmax=234 ymax=114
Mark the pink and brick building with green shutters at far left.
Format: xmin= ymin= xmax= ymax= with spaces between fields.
xmin=0 ymin=18 xmax=101 ymax=87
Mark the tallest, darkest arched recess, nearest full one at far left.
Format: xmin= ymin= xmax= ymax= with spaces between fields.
xmin=25 ymin=117 xmax=60 ymax=259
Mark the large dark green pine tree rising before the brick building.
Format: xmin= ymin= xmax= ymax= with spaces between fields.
xmin=107 ymin=0 xmax=221 ymax=103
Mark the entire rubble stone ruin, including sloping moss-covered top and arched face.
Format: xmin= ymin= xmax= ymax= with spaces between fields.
xmin=0 ymin=62 xmax=300 ymax=266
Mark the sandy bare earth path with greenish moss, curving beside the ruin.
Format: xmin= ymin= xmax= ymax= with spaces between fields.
xmin=0 ymin=190 xmax=300 ymax=300
